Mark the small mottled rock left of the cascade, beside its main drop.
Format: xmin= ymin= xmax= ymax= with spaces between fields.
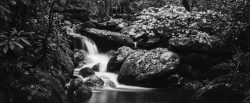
xmin=74 ymin=50 xmax=87 ymax=66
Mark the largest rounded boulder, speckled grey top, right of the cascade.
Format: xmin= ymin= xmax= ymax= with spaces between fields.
xmin=118 ymin=48 xmax=180 ymax=86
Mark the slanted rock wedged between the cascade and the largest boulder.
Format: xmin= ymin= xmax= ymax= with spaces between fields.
xmin=107 ymin=46 xmax=135 ymax=72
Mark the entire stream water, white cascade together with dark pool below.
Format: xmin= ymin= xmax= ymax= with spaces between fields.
xmin=68 ymin=27 xmax=191 ymax=103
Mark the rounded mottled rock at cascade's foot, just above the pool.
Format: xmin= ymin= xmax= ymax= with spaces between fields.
xmin=84 ymin=76 xmax=104 ymax=88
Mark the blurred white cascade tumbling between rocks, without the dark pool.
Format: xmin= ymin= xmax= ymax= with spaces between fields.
xmin=67 ymin=26 xmax=152 ymax=89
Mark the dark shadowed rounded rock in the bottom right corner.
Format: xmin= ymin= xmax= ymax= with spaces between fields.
xmin=194 ymin=84 xmax=245 ymax=103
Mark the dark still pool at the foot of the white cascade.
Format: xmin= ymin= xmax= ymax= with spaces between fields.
xmin=86 ymin=89 xmax=193 ymax=103
